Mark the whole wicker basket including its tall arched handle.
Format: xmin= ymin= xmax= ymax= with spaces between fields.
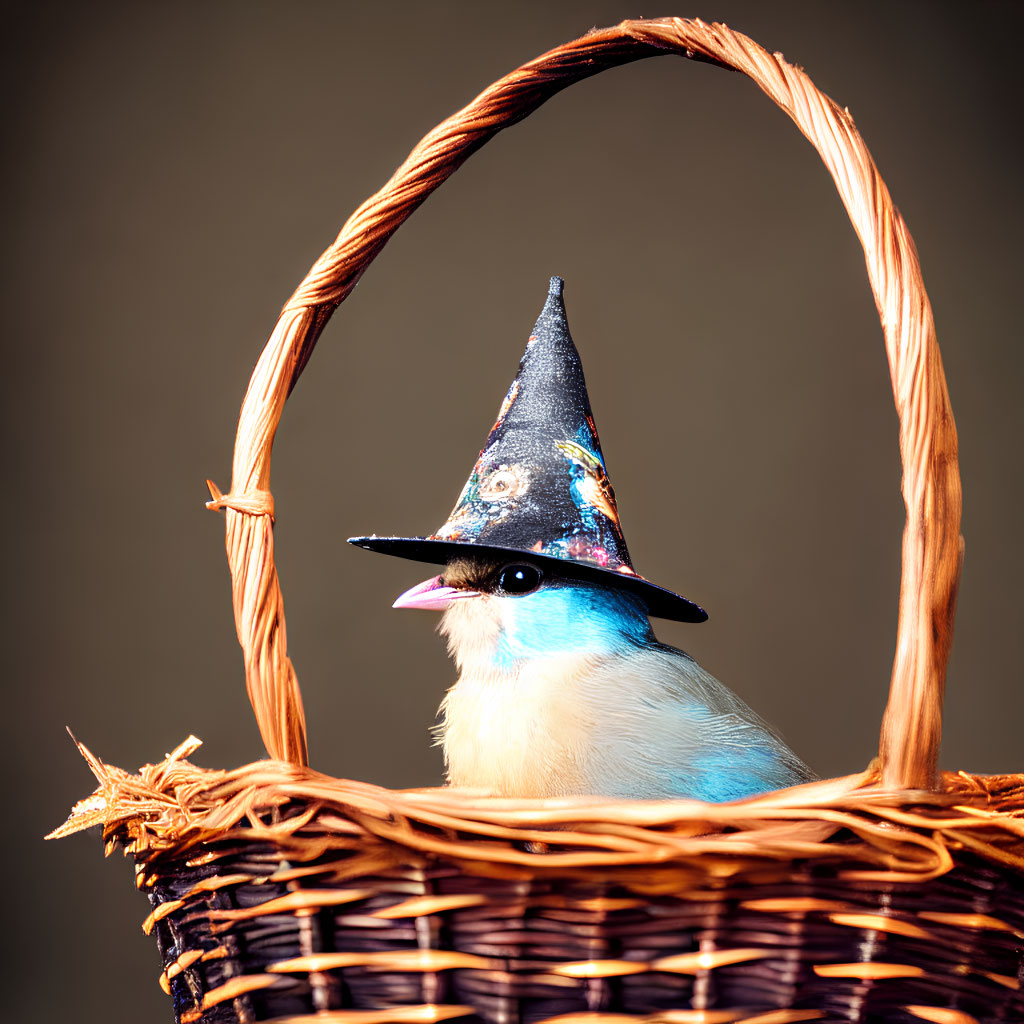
xmin=53 ymin=18 xmax=1024 ymax=1024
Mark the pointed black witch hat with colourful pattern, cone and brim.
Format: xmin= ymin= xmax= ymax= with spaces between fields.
xmin=349 ymin=278 xmax=708 ymax=623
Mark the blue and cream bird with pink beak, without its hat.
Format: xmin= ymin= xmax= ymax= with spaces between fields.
xmin=394 ymin=553 xmax=814 ymax=803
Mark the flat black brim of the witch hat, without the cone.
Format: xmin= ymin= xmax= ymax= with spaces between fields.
xmin=348 ymin=537 xmax=708 ymax=623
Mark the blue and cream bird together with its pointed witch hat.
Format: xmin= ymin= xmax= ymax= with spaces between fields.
xmin=349 ymin=278 xmax=814 ymax=802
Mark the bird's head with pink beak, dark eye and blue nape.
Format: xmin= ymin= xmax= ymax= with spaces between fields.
xmin=394 ymin=553 xmax=653 ymax=671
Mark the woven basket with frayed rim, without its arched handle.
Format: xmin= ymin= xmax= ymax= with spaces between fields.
xmin=60 ymin=740 xmax=1024 ymax=1024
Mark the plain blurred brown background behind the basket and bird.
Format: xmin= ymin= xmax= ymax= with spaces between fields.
xmin=2 ymin=0 xmax=1024 ymax=1022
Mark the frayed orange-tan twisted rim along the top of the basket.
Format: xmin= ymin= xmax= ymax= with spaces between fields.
xmin=47 ymin=736 xmax=1024 ymax=883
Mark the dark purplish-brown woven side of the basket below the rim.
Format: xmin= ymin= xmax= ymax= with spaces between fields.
xmin=141 ymin=827 xmax=1024 ymax=1024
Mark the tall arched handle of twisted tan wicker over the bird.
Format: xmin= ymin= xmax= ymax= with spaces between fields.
xmin=209 ymin=18 xmax=963 ymax=788
